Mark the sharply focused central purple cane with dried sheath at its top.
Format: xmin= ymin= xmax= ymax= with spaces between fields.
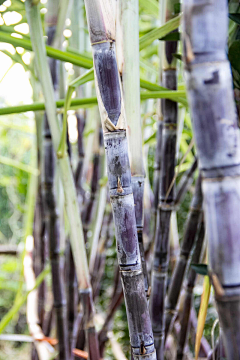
xmin=85 ymin=0 xmax=156 ymax=359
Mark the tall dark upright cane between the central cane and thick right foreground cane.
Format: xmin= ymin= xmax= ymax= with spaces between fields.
xmin=150 ymin=0 xmax=177 ymax=360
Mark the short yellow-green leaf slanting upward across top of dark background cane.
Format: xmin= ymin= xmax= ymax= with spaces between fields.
xmin=139 ymin=15 xmax=181 ymax=50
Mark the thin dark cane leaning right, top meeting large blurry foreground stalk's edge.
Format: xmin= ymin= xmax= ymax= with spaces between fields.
xmin=165 ymin=176 xmax=203 ymax=340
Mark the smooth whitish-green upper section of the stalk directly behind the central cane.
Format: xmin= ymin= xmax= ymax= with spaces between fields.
xmin=116 ymin=0 xmax=145 ymax=176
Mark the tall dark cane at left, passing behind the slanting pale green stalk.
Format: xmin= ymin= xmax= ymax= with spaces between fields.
xmin=42 ymin=1 xmax=69 ymax=360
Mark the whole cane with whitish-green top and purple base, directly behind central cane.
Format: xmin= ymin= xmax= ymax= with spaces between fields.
xmin=116 ymin=0 xmax=149 ymax=296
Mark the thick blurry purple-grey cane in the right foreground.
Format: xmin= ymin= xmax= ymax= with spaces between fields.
xmin=183 ymin=0 xmax=240 ymax=360
